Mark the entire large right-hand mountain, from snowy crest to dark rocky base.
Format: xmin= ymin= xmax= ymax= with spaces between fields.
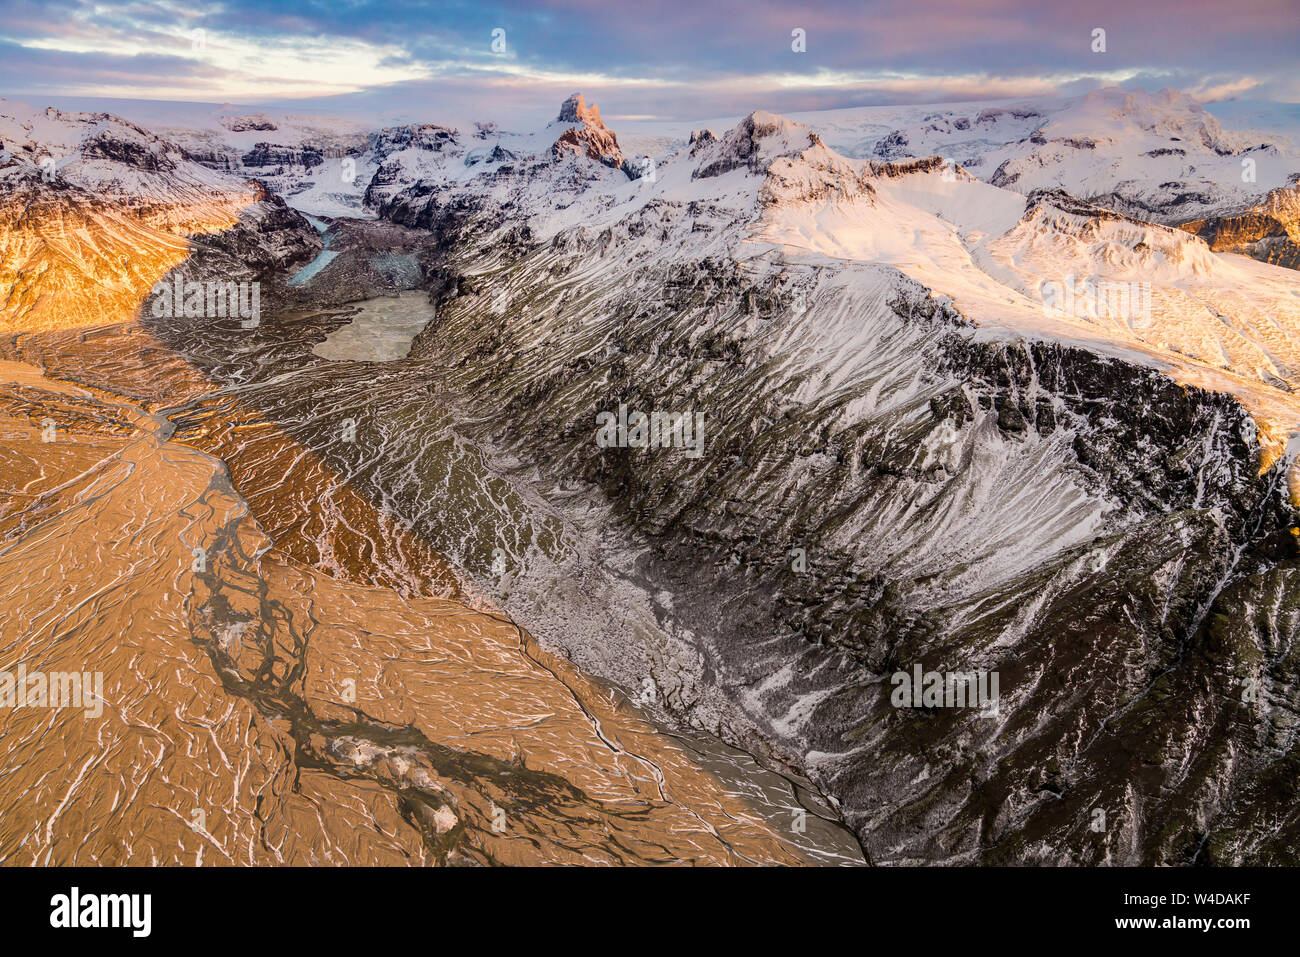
xmin=358 ymin=98 xmax=1297 ymax=863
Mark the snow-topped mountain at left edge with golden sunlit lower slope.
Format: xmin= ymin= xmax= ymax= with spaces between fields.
xmin=0 ymin=100 xmax=320 ymax=332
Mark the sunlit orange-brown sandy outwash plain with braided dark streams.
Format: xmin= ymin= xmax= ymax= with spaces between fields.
xmin=0 ymin=343 xmax=863 ymax=865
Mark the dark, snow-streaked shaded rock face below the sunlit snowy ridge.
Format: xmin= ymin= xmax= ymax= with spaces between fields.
xmin=384 ymin=183 xmax=1300 ymax=865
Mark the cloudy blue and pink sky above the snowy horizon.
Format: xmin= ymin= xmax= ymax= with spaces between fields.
xmin=0 ymin=0 xmax=1300 ymax=120
